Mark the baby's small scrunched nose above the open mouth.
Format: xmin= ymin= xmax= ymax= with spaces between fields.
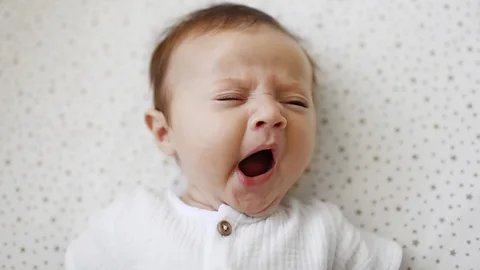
xmin=250 ymin=101 xmax=287 ymax=130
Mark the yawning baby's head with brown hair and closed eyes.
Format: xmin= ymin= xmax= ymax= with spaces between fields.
xmin=145 ymin=4 xmax=316 ymax=216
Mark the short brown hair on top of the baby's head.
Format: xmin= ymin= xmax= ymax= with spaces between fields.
xmin=150 ymin=3 xmax=316 ymax=121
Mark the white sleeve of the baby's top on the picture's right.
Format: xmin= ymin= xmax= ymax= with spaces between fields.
xmin=330 ymin=205 xmax=402 ymax=270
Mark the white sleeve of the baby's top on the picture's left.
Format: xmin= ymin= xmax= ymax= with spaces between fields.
xmin=64 ymin=192 xmax=133 ymax=270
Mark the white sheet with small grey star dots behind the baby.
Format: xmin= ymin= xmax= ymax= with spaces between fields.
xmin=0 ymin=0 xmax=480 ymax=270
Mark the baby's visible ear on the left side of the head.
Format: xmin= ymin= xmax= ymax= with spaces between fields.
xmin=145 ymin=109 xmax=176 ymax=156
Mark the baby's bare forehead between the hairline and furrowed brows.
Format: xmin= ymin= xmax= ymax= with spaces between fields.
xmin=167 ymin=26 xmax=313 ymax=88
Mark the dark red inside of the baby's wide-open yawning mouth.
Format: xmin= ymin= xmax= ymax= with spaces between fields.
xmin=238 ymin=149 xmax=275 ymax=177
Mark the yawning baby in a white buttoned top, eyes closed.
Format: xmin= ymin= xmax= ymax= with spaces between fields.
xmin=65 ymin=4 xmax=402 ymax=270
